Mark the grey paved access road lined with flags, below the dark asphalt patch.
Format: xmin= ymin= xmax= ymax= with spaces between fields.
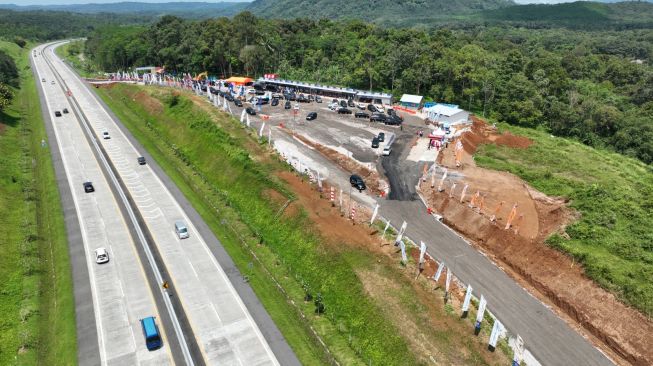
xmin=379 ymin=200 xmax=612 ymax=366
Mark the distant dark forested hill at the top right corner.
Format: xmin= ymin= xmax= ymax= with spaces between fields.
xmin=480 ymin=1 xmax=653 ymax=30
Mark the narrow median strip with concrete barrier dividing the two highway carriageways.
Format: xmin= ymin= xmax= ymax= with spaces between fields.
xmin=41 ymin=44 xmax=205 ymax=366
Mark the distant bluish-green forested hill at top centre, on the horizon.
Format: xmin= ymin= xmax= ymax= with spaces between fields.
xmin=247 ymin=0 xmax=514 ymax=25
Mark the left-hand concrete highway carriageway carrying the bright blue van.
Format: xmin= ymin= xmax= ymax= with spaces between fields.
xmin=32 ymin=46 xmax=174 ymax=365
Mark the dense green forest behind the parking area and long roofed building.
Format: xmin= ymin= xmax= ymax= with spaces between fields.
xmin=86 ymin=12 xmax=653 ymax=164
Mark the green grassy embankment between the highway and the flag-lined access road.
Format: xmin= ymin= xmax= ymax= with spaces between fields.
xmin=94 ymin=85 xmax=500 ymax=365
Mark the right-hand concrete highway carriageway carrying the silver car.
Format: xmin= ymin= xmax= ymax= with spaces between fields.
xmin=38 ymin=45 xmax=299 ymax=365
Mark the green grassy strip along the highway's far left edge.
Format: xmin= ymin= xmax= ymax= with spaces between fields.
xmin=0 ymin=42 xmax=77 ymax=365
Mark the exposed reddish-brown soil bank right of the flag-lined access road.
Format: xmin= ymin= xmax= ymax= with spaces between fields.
xmin=420 ymin=119 xmax=653 ymax=365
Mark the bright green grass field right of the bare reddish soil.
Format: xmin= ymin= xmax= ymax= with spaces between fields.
xmin=475 ymin=125 xmax=653 ymax=317
